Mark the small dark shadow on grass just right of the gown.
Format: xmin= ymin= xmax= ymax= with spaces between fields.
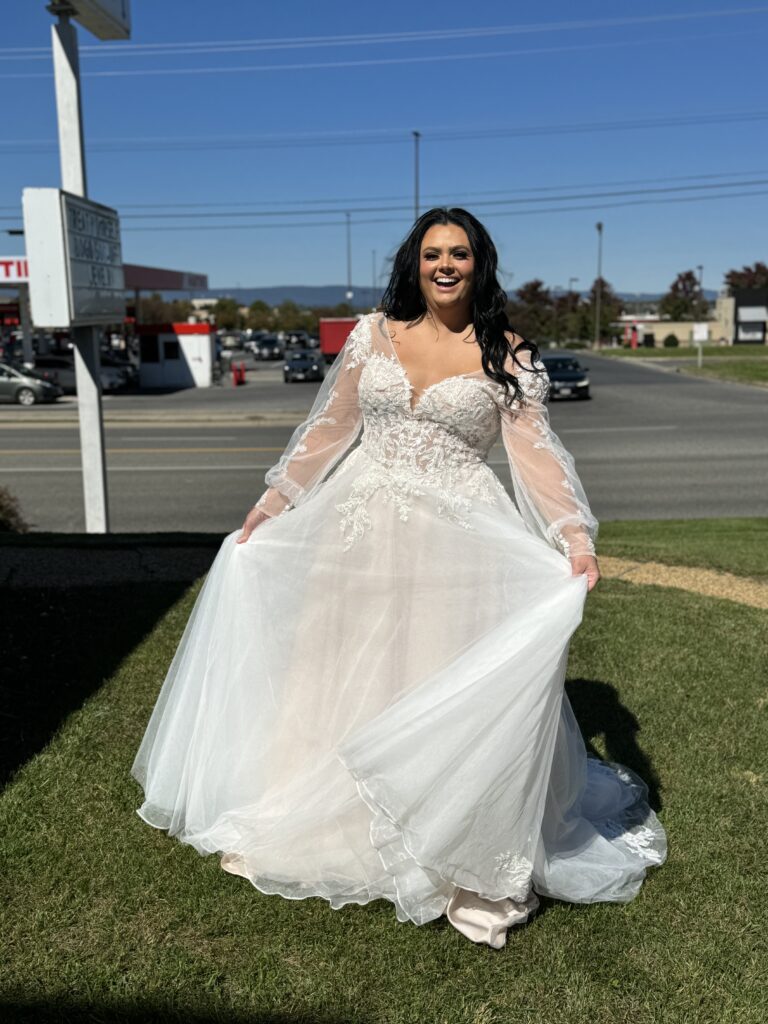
xmin=565 ymin=679 xmax=662 ymax=811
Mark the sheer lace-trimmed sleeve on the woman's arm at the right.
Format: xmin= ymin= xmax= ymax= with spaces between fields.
xmin=501 ymin=352 xmax=598 ymax=558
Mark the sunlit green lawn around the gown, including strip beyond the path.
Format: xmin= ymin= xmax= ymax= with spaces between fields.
xmin=0 ymin=520 xmax=768 ymax=1024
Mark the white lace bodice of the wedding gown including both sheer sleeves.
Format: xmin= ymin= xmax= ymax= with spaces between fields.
xmin=257 ymin=313 xmax=597 ymax=554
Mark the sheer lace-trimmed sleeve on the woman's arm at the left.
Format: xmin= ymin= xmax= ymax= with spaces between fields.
xmin=256 ymin=321 xmax=366 ymax=516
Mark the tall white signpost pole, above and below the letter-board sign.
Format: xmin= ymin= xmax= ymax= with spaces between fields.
xmin=51 ymin=5 xmax=110 ymax=534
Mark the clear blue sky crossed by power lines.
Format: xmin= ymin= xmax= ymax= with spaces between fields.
xmin=0 ymin=0 xmax=768 ymax=292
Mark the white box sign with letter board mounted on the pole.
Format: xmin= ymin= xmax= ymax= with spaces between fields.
xmin=23 ymin=188 xmax=125 ymax=327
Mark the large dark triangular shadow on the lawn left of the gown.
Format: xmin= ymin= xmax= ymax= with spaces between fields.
xmin=0 ymin=535 xmax=219 ymax=785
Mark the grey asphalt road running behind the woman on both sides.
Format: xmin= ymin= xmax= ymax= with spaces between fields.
xmin=0 ymin=353 xmax=768 ymax=532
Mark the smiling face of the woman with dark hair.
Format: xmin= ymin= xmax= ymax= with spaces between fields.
xmin=419 ymin=224 xmax=475 ymax=309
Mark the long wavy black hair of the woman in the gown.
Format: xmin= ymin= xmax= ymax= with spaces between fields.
xmin=379 ymin=206 xmax=539 ymax=404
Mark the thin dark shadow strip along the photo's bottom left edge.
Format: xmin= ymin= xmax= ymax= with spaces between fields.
xmin=0 ymin=999 xmax=374 ymax=1024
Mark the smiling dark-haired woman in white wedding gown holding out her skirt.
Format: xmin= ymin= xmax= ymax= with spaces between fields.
xmin=133 ymin=209 xmax=666 ymax=948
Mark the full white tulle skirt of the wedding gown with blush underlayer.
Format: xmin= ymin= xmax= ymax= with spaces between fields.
xmin=133 ymin=450 xmax=666 ymax=925
